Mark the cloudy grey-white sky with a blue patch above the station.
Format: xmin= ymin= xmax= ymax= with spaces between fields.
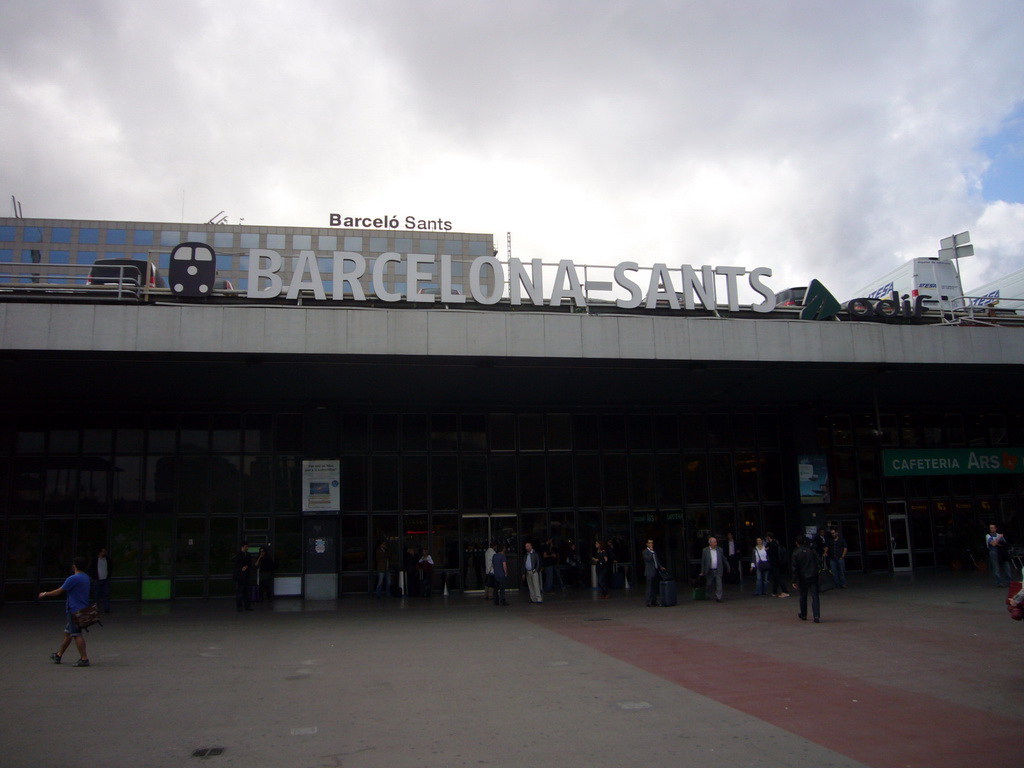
xmin=0 ymin=0 xmax=1024 ymax=298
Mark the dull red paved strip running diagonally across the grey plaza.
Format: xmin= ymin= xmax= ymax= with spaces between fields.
xmin=532 ymin=616 xmax=1024 ymax=768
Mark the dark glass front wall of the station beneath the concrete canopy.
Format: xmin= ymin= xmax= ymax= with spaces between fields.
xmin=0 ymin=411 xmax=1024 ymax=601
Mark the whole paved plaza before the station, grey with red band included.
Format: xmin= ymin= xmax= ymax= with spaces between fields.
xmin=0 ymin=572 xmax=1024 ymax=768
